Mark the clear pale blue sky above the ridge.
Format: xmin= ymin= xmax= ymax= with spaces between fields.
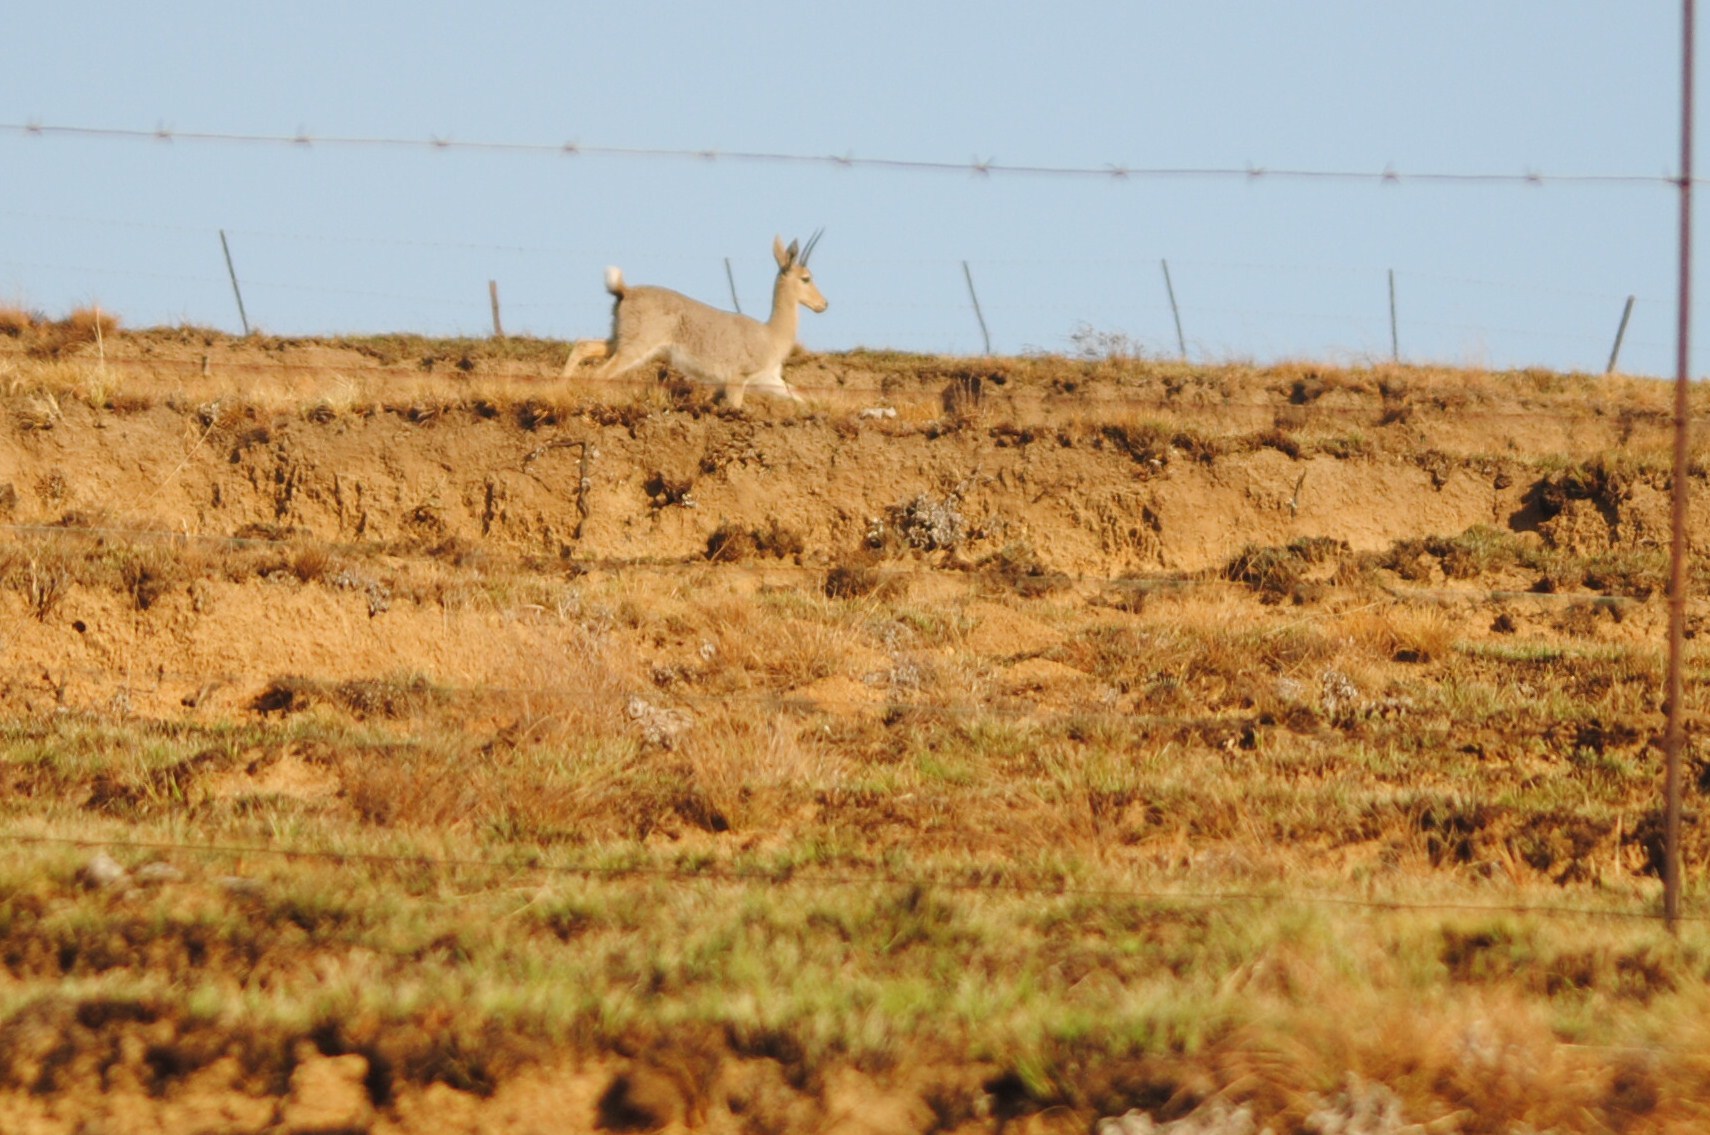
xmin=0 ymin=0 xmax=1710 ymax=374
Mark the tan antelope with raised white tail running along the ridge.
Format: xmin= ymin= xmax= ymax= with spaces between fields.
xmin=564 ymin=229 xmax=826 ymax=409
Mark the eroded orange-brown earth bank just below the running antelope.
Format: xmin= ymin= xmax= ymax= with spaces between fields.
xmin=0 ymin=336 xmax=1682 ymax=576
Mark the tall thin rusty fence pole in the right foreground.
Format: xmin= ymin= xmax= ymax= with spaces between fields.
xmin=1662 ymin=0 xmax=1695 ymax=933
